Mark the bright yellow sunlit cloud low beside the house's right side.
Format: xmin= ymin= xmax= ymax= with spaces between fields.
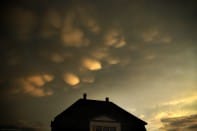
xmin=145 ymin=92 xmax=197 ymax=130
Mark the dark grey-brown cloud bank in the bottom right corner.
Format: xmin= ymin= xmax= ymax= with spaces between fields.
xmin=161 ymin=115 xmax=197 ymax=131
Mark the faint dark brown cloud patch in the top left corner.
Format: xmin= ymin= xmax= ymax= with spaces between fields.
xmin=4 ymin=7 xmax=37 ymax=40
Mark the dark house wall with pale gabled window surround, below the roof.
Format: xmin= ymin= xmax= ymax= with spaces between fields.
xmin=51 ymin=116 xmax=146 ymax=131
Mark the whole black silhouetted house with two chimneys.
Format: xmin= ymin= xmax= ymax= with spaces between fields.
xmin=51 ymin=94 xmax=147 ymax=131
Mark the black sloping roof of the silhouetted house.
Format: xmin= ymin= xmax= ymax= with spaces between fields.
xmin=54 ymin=99 xmax=147 ymax=125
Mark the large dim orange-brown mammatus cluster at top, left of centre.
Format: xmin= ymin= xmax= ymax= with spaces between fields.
xmin=61 ymin=7 xmax=100 ymax=47
